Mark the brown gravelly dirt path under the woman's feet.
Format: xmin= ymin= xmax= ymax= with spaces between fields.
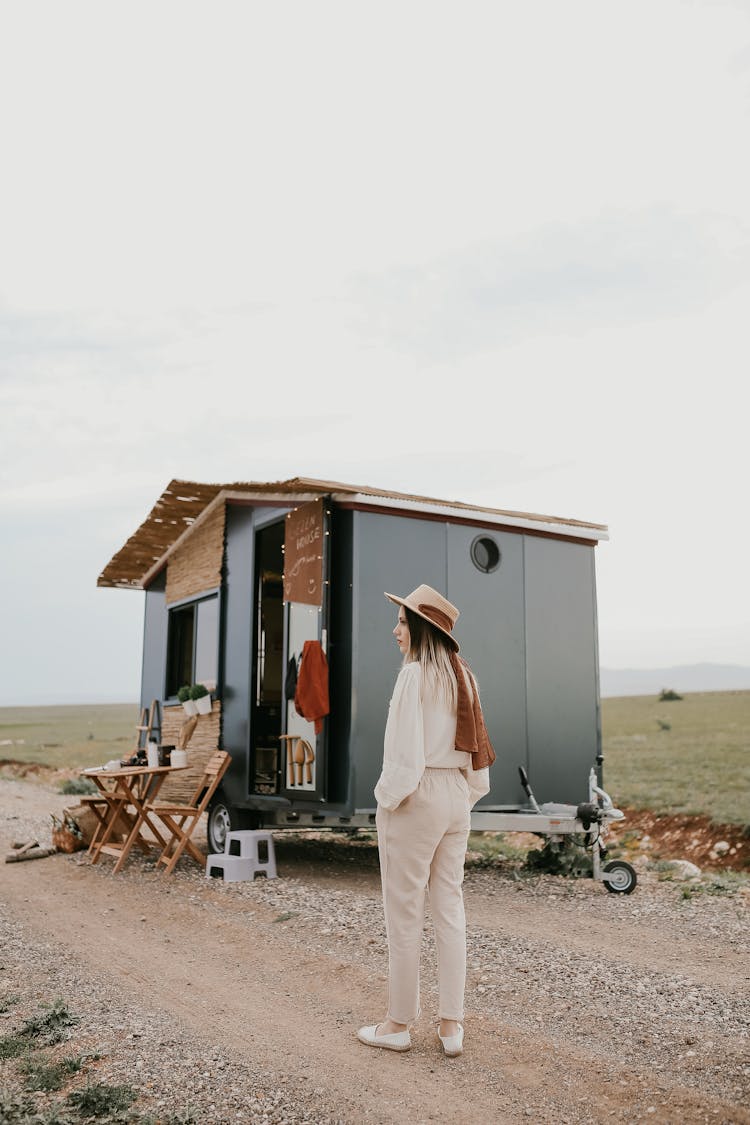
xmin=0 ymin=782 xmax=750 ymax=1125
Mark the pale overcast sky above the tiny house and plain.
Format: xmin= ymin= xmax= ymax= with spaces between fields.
xmin=0 ymin=0 xmax=750 ymax=705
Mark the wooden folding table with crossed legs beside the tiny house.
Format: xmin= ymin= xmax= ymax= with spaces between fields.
xmin=81 ymin=765 xmax=187 ymax=873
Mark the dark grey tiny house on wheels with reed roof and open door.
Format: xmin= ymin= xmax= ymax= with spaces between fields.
xmin=98 ymin=478 xmax=607 ymax=877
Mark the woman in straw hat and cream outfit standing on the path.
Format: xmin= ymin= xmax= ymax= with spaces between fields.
xmin=358 ymin=585 xmax=495 ymax=1055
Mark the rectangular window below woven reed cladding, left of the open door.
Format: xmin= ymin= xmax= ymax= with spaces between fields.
xmin=166 ymin=594 xmax=219 ymax=699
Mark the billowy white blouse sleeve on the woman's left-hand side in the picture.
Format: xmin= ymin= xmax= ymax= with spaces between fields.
xmin=374 ymin=663 xmax=425 ymax=812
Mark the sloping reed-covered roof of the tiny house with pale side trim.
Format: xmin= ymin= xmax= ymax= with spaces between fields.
xmin=97 ymin=477 xmax=608 ymax=590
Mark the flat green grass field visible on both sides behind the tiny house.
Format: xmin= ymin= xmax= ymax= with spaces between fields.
xmin=0 ymin=692 xmax=750 ymax=825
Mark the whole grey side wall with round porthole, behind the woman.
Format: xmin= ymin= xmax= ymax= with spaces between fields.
xmin=351 ymin=512 xmax=598 ymax=809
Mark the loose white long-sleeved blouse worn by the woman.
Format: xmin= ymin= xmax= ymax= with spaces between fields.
xmin=374 ymin=660 xmax=489 ymax=811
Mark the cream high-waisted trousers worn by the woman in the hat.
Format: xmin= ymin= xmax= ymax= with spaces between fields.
xmin=376 ymin=768 xmax=471 ymax=1024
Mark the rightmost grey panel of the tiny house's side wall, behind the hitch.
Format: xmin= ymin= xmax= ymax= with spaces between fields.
xmin=525 ymin=537 xmax=599 ymax=803
